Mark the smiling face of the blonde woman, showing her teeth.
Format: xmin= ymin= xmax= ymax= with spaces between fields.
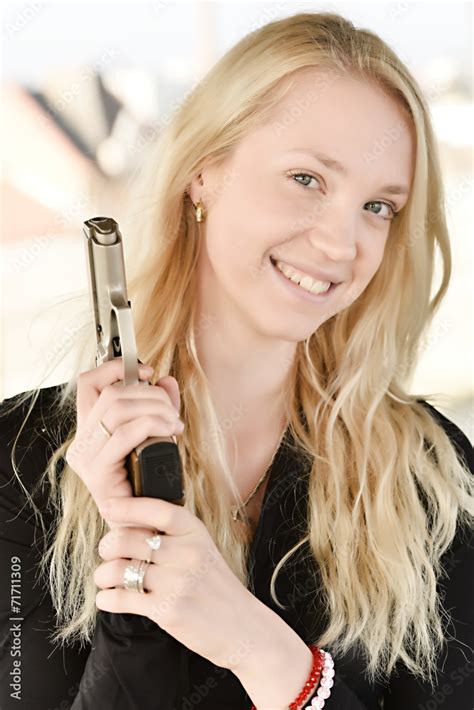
xmin=190 ymin=68 xmax=415 ymax=342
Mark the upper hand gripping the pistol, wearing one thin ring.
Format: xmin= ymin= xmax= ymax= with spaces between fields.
xmin=66 ymin=357 xmax=184 ymax=527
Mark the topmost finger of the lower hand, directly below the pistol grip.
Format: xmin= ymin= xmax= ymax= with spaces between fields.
xmin=100 ymin=496 xmax=193 ymax=535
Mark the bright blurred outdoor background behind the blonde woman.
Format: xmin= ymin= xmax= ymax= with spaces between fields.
xmin=0 ymin=0 xmax=474 ymax=441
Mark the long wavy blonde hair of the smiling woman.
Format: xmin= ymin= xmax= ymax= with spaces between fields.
xmin=2 ymin=12 xmax=474 ymax=682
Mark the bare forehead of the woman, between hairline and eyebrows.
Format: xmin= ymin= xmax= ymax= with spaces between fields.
xmin=242 ymin=67 xmax=415 ymax=182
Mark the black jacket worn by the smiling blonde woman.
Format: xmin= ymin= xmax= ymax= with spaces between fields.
xmin=0 ymin=385 xmax=474 ymax=710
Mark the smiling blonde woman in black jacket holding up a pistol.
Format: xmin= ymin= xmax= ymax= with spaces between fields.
xmin=1 ymin=13 xmax=474 ymax=710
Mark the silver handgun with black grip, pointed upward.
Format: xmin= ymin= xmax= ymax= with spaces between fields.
xmin=83 ymin=217 xmax=184 ymax=505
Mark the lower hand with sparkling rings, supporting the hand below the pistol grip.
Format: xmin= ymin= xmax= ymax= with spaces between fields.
xmin=94 ymin=497 xmax=263 ymax=670
